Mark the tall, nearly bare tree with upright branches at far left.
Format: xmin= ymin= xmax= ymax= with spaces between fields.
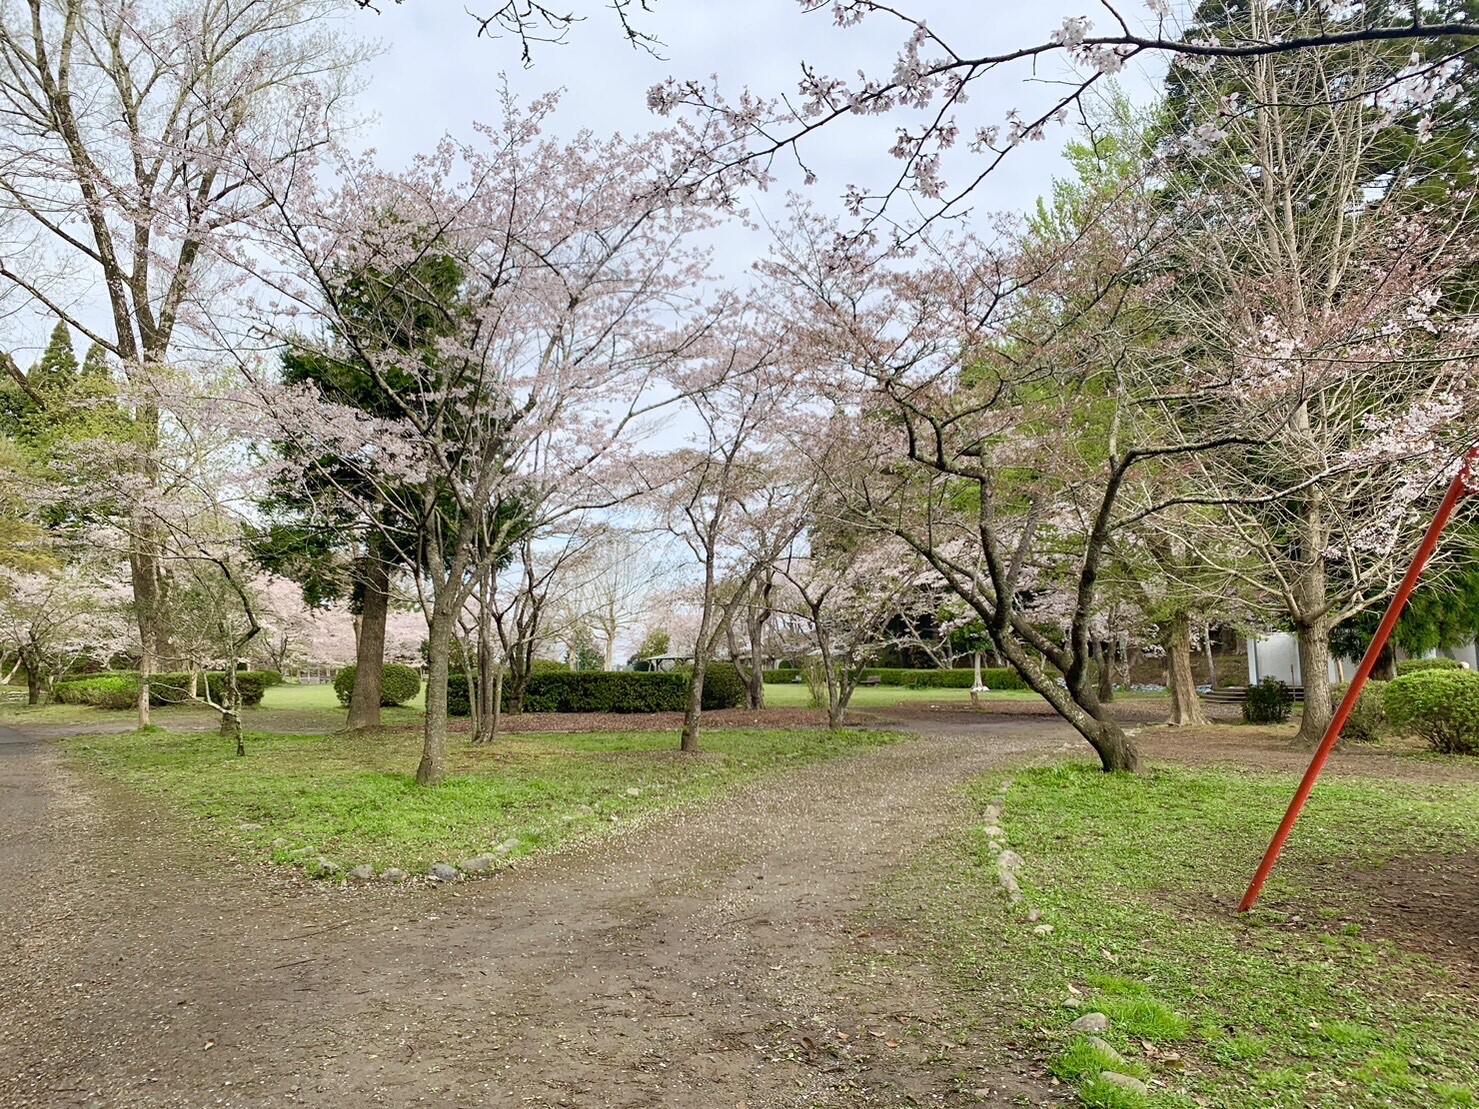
xmin=0 ymin=0 xmax=358 ymax=726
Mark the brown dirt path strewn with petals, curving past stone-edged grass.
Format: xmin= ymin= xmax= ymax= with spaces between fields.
xmin=0 ymin=717 xmax=1088 ymax=1109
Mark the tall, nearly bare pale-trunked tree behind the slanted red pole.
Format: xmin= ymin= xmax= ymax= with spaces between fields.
xmin=1162 ymin=17 xmax=1479 ymax=742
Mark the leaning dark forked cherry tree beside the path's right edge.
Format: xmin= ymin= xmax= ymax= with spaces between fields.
xmin=769 ymin=175 xmax=1242 ymax=770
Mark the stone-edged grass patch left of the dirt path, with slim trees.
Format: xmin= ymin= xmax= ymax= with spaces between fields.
xmin=71 ymin=729 xmax=901 ymax=874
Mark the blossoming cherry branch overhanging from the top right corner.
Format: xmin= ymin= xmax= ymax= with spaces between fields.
xmin=648 ymin=0 xmax=1475 ymax=237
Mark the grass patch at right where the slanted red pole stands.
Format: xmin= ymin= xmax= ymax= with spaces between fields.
xmin=889 ymin=764 xmax=1479 ymax=1109
